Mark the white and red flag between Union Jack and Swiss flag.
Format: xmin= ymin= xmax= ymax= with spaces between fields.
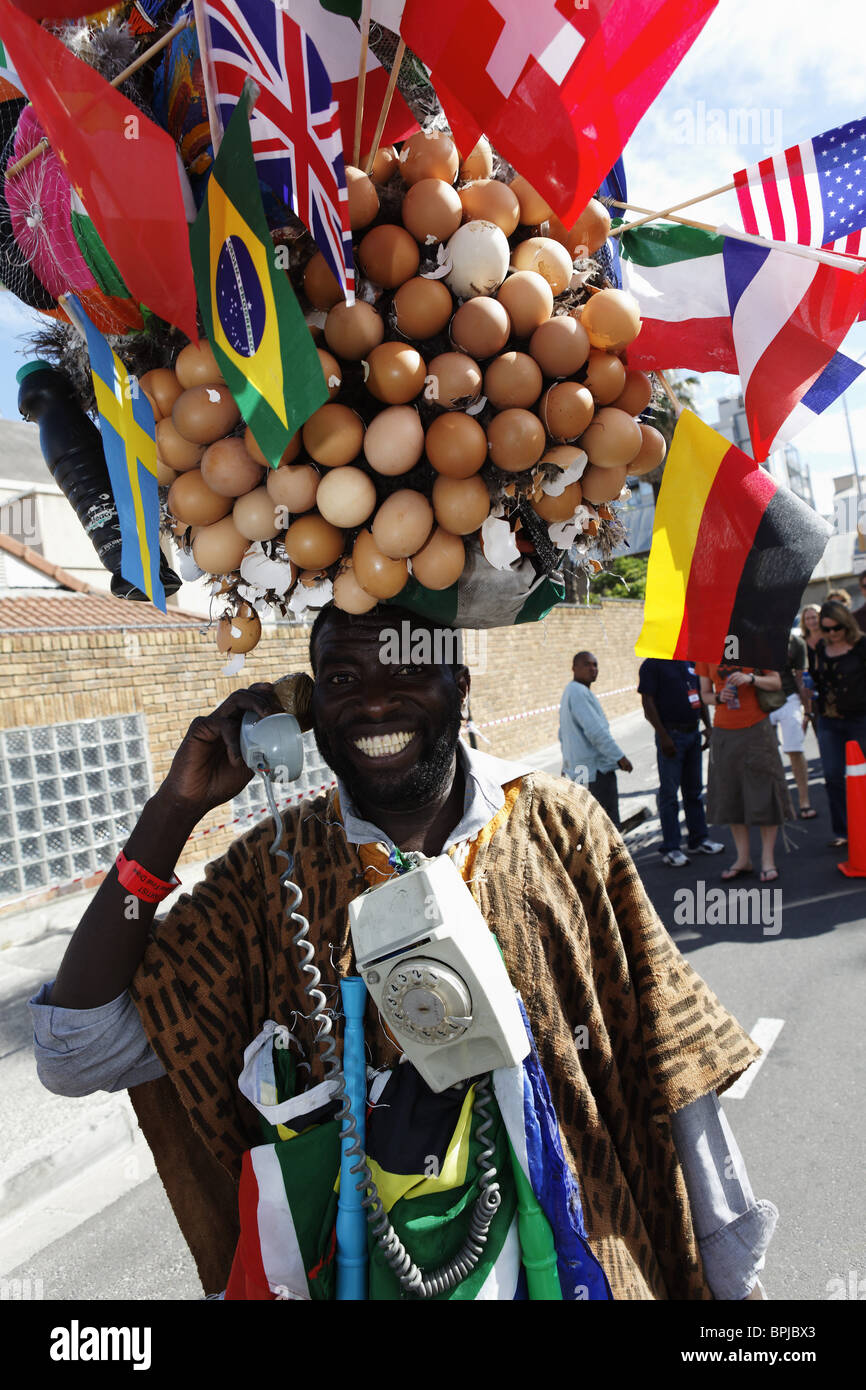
xmin=278 ymin=0 xmax=418 ymax=164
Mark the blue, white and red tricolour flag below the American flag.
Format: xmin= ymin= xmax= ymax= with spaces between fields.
xmin=723 ymin=238 xmax=866 ymax=463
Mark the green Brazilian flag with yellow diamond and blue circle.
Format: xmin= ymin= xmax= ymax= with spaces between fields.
xmin=190 ymin=88 xmax=328 ymax=467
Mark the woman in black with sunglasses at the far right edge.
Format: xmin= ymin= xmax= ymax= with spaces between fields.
xmin=809 ymin=602 xmax=866 ymax=849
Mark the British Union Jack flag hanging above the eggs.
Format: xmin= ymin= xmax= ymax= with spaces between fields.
xmin=204 ymin=0 xmax=354 ymax=304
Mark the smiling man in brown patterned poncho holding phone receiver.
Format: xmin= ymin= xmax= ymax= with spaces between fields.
xmin=32 ymin=609 xmax=777 ymax=1300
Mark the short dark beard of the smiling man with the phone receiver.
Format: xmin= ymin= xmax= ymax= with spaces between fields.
xmin=313 ymin=685 xmax=461 ymax=812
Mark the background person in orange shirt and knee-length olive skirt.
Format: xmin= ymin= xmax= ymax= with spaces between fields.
xmin=695 ymin=662 xmax=794 ymax=883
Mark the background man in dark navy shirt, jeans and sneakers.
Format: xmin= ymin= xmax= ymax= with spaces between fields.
xmin=638 ymin=657 xmax=724 ymax=869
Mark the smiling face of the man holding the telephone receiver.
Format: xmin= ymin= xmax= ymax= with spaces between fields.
xmin=313 ymin=621 xmax=468 ymax=812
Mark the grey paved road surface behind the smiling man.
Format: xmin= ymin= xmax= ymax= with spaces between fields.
xmin=8 ymin=716 xmax=866 ymax=1301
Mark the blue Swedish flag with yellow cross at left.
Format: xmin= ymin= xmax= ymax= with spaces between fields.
xmin=65 ymin=295 xmax=165 ymax=613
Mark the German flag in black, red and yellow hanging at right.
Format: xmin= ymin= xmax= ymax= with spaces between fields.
xmin=635 ymin=410 xmax=831 ymax=670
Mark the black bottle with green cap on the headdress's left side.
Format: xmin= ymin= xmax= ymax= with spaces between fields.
xmin=17 ymin=361 xmax=181 ymax=603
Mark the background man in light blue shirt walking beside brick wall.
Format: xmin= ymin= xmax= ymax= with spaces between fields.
xmin=559 ymin=652 xmax=632 ymax=830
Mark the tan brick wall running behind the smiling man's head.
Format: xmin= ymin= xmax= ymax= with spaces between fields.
xmin=0 ymin=600 xmax=642 ymax=895
